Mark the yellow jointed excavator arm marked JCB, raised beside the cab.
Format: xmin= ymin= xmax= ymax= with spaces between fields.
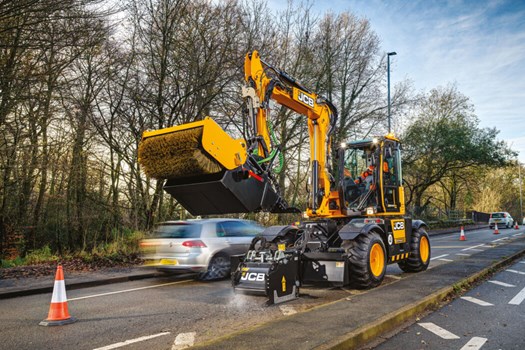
xmin=243 ymin=51 xmax=339 ymax=217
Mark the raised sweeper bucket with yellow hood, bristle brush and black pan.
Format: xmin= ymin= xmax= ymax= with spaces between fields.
xmin=138 ymin=118 xmax=289 ymax=215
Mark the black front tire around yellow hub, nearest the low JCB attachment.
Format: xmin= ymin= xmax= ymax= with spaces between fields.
xmin=348 ymin=232 xmax=387 ymax=289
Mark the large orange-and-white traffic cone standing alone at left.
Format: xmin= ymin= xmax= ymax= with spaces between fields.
xmin=39 ymin=265 xmax=77 ymax=326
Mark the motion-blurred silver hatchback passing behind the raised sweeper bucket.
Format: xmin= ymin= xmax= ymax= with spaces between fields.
xmin=140 ymin=219 xmax=264 ymax=280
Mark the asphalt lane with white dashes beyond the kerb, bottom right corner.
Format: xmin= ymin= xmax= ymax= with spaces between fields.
xmin=375 ymin=260 xmax=525 ymax=350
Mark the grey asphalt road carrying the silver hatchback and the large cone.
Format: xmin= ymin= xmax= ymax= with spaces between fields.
xmin=0 ymin=229 xmax=525 ymax=350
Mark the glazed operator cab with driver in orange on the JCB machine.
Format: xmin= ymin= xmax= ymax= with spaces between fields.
xmin=338 ymin=135 xmax=404 ymax=216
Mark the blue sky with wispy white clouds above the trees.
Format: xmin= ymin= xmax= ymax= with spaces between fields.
xmin=269 ymin=0 xmax=525 ymax=163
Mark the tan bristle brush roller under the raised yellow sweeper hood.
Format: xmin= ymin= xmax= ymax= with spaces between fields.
xmin=138 ymin=127 xmax=223 ymax=179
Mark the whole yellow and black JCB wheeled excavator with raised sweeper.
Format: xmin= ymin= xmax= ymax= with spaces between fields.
xmin=139 ymin=51 xmax=430 ymax=303
